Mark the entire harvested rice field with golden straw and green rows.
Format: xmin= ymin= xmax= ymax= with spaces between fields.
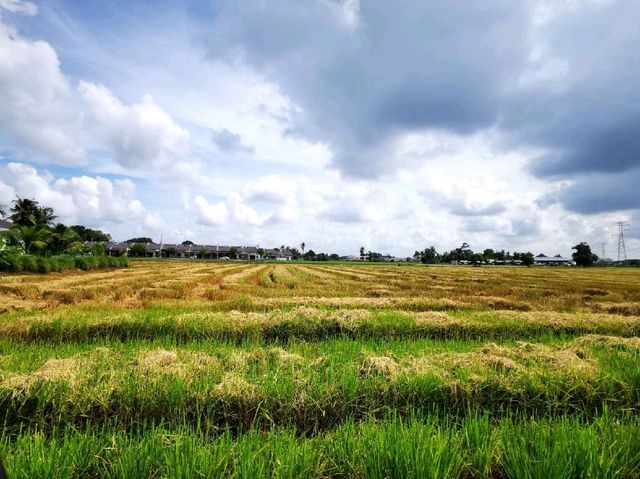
xmin=0 ymin=260 xmax=640 ymax=479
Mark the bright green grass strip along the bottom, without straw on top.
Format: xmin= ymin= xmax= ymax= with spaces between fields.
xmin=0 ymin=414 xmax=640 ymax=479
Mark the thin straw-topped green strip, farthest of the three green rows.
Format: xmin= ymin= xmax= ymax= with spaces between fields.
xmin=0 ymin=307 xmax=640 ymax=343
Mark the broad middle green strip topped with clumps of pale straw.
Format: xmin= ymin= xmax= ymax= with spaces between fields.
xmin=0 ymin=335 xmax=640 ymax=434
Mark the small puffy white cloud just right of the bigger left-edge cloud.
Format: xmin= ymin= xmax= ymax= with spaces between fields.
xmin=78 ymin=81 xmax=189 ymax=169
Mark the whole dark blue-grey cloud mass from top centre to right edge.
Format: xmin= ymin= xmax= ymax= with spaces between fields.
xmin=208 ymin=0 xmax=640 ymax=212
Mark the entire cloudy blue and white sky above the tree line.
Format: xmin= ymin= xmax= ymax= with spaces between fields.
xmin=0 ymin=0 xmax=640 ymax=258
